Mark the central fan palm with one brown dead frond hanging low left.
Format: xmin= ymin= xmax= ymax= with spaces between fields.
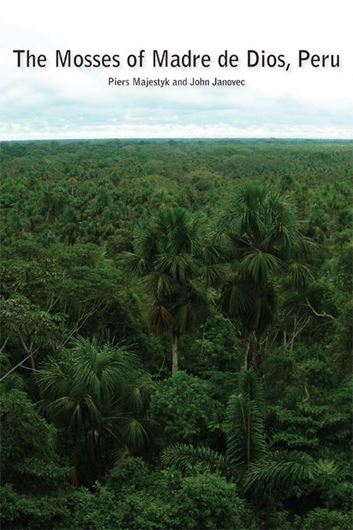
xmin=123 ymin=208 xmax=206 ymax=374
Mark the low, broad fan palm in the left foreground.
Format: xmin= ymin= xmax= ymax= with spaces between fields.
xmin=38 ymin=338 xmax=153 ymax=480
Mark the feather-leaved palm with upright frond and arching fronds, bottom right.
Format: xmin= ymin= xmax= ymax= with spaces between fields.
xmin=162 ymin=369 xmax=324 ymax=500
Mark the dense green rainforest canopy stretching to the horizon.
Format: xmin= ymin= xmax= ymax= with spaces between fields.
xmin=0 ymin=140 xmax=353 ymax=530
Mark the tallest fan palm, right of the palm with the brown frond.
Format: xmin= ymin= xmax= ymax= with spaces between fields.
xmin=219 ymin=181 xmax=309 ymax=368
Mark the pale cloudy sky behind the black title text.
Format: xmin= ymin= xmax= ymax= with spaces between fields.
xmin=0 ymin=0 xmax=353 ymax=140
